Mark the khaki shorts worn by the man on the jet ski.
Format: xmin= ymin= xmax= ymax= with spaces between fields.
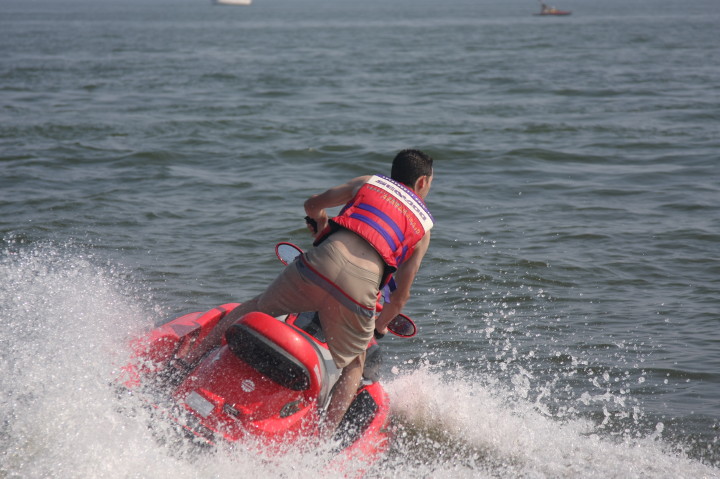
xmin=258 ymin=236 xmax=381 ymax=368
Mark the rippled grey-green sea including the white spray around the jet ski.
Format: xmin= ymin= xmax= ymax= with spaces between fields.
xmin=0 ymin=0 xmax=720 ymax=479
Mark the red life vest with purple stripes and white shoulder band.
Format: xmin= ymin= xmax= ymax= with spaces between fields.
xmin=315 ymin=175 xmax=433 ymax=272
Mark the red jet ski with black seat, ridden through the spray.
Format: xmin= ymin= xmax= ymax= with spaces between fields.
xmin=120 ymin=243 xmax=417 ymax=467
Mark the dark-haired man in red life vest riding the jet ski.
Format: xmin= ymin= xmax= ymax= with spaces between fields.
xmin=187 ymin=150 xmax=433 ymax=434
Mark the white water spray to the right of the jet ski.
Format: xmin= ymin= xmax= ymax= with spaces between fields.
xmin=387 ymin=366 xmax=720 ymax=478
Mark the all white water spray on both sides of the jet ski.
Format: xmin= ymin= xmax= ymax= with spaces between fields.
xmin=0 ymin=241 xmax=718 ymax=479
